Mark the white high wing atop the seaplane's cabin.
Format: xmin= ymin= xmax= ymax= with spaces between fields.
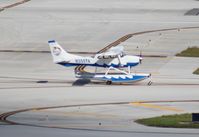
xmin=96 ymin=46 xmax=124 ymax=59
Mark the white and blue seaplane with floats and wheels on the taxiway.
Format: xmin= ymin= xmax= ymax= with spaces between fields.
xmin=48 ymin=40 xmax=151 ymax=85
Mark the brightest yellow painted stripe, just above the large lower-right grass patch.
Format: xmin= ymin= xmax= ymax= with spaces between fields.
xmin=130 ymin=102 xmax=183 ymax=112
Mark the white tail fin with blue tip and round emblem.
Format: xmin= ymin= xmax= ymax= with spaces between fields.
xmin=48 ymin=40 xmax=71 ymax=63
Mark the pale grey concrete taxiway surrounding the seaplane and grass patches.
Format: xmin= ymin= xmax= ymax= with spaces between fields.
xmin=0 ymin=0 xmax=199 ymax=137
